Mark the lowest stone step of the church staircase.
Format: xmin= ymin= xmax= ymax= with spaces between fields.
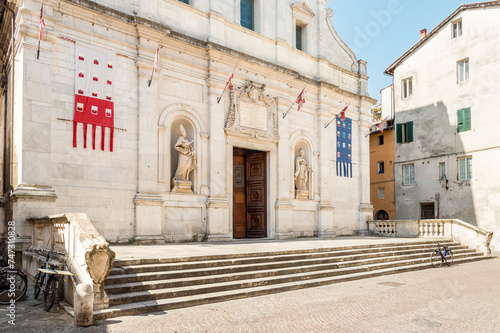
xmin=94 ymin=254 xmax=491 ymax=320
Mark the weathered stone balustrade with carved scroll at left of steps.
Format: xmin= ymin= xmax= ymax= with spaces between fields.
xmin=23 ymin=214 xmax=115 ymax=310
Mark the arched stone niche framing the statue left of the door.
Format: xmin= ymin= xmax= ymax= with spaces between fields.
xmin=158 ymin=104 xmax=204 ymax=193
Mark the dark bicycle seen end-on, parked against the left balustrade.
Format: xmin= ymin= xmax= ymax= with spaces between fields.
xmin=34 ymin=252 xmax=73 ymax=311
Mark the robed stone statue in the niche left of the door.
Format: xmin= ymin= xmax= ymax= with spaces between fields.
xmin=172 ymin=124 xmax=198 ymax=193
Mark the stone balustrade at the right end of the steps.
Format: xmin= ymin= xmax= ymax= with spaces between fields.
xmin=367 ymin=219 xmax=493 ymax=255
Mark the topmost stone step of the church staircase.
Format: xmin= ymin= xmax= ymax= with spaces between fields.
xmin=113 ymin=239 xmax=457 ymax=267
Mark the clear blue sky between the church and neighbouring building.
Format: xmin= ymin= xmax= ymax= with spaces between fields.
xmin=328 ymin=0 xmax=480 ymax=104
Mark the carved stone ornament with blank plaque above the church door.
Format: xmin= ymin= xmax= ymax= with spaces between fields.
xmin=225 ymin=81 xmax=279 ymax=141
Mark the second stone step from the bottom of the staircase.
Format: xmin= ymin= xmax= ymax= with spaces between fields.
xmin=103 ymin=253 xmax=477 ymax=305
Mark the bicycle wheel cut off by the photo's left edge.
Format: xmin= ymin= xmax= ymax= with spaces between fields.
xmin=0 ymin=266 xmax=28 ymax=304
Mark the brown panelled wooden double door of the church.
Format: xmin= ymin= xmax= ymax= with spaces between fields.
xmin=233 ymin=148 xmax=267 ymax=239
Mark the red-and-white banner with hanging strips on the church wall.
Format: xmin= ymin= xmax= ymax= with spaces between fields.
xmin=73 ymin=44 xmax=115 ymax=151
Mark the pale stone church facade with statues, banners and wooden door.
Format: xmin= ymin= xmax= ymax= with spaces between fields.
xmin=1 ymin=0 xmax=375 ymax=249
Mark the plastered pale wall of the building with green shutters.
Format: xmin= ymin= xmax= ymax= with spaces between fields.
xmin=386 ymin=2 xmax=500 ymax=250
